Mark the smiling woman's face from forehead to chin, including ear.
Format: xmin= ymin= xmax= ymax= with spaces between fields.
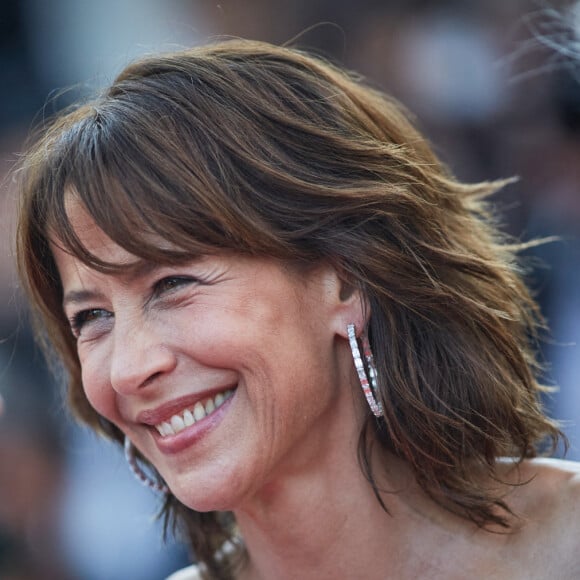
xmin=53 ymin=204 xmax=362 ymax=511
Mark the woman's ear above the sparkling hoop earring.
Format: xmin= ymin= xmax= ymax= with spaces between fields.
xmin=325 ymin=268 xmax=370 ymax=338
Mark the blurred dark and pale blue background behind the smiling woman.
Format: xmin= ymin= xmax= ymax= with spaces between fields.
xmin=0 ymin=0 xmax=580 ymax=580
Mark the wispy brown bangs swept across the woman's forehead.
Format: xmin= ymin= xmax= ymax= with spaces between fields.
xmin=45 ymin=119 xmax=225 ymax=271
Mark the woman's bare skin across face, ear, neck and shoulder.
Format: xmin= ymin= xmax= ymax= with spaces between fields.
xmin=52 ymin=202 xmax=580 ymax=580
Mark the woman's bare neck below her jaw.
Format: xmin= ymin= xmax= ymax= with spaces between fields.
xmin=236 ymin=428 xmax=432 ymax=580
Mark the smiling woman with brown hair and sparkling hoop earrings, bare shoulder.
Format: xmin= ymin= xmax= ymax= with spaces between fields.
xmin=19 ymin=41 xmax=580 ymax=579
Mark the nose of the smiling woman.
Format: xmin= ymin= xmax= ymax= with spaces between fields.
xmin=110 ymin=319 xmax=177 ymax=395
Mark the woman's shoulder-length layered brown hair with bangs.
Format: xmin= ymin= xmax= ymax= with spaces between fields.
xmin=18 ymin=41 xmax=561 ymax=577
